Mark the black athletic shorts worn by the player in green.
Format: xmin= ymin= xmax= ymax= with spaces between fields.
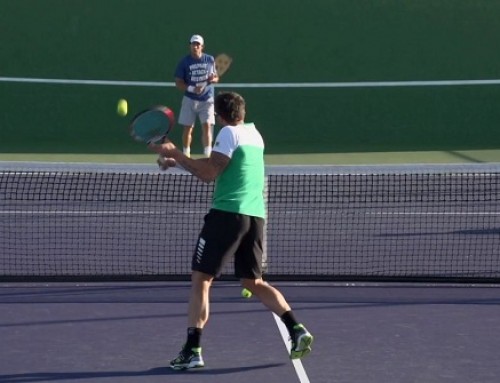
xmin=192 ymin=209 xmax=264 ymax=279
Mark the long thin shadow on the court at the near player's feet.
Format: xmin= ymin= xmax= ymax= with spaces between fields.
xmin=0 ymin=363 xmax=285 ymax=383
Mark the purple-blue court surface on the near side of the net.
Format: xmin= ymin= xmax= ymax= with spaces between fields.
xmin=0 ymin=281 xmax=500 ymax=383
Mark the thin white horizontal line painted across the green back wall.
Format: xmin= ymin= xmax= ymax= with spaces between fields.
xmin=0 ymin=77 xmax=500 ymax=88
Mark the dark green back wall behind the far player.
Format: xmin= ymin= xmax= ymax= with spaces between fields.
xmin=0 ymin=0 xmax=500 ymax=153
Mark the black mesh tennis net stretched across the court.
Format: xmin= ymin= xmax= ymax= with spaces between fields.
xmin=0 ymin=162 xmax=500 ymax=281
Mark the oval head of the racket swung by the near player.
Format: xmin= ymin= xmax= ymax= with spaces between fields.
xmin=129 ymin=105 xmax=175 ymax=144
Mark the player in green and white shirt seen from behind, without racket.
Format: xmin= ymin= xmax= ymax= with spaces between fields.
xmin=149 ymin=92 xmax=313 ymax=370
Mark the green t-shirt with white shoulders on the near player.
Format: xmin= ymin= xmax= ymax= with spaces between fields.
xmin=212 ymin=124 xmax=266 ymax=218
